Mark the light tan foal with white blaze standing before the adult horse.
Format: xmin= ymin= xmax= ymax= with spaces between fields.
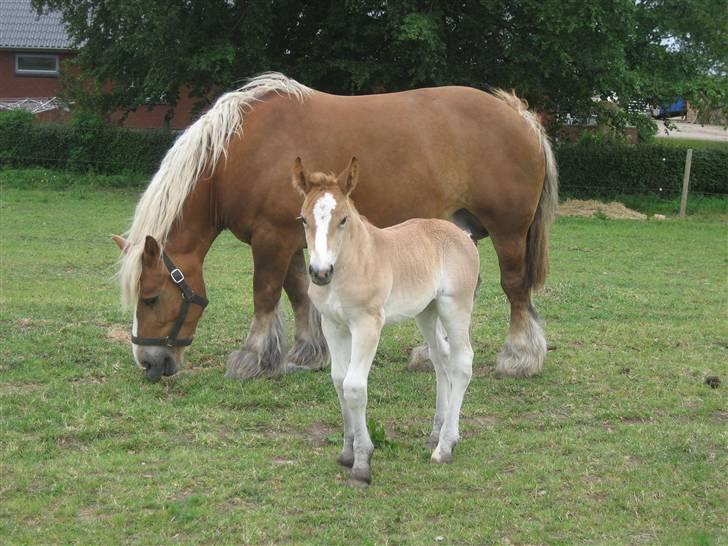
xmin=293 ymin=158 xmax=480 ymax=484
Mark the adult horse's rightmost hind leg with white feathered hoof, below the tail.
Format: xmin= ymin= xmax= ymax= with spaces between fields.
xmin=491 ymin=233 xmax=546 ymax=377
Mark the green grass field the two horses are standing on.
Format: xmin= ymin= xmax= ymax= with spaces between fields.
xmin=0 ymin=177 xmax=728 ymax=545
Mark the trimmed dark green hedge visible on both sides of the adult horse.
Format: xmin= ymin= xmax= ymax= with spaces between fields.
xmin=0 ymin=111 xmax=728 ymax=197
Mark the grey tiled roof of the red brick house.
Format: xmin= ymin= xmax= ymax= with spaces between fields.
xmin=0 ymin=0 xmax=72 ymax=49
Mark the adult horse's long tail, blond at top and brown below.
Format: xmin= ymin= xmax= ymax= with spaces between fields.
xmin=494 ymin=89 xmax=559 ymax=290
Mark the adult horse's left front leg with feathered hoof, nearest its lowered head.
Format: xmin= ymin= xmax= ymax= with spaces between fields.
xmin=225 ymin=233 xmax=293 ymax=379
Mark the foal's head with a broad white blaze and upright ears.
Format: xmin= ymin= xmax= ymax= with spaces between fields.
xmin=293 ymin=157 xmax=359 ymax=285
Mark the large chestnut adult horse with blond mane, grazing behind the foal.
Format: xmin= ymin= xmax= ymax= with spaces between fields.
xmin=115 ymin=73 xmax=557 ymax=379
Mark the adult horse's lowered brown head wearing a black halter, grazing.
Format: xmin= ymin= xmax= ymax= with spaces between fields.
xmin=114 ymin=235 xmax=207 ymax=381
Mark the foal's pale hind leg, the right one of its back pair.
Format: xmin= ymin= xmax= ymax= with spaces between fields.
xmin=432 ymin=293 xmax=473 ymax=463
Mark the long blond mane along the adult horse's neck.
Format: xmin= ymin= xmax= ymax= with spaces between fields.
xmin=119 ymin=72 xmax=313 ymax=306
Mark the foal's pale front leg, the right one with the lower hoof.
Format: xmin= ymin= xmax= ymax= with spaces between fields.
xmin=342 ymin=313 xmax=384 ymax=485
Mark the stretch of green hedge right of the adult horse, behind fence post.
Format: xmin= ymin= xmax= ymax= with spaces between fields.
xmin=556 ymin=143 xmax=728 ymax=197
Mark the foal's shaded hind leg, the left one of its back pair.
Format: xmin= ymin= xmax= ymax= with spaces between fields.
xmin=415 ymin=303 xmax=450 ymax=448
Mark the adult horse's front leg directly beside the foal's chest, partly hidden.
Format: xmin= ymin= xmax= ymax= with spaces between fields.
xmin=283 ymin=250 xmax=330 ymax=371
